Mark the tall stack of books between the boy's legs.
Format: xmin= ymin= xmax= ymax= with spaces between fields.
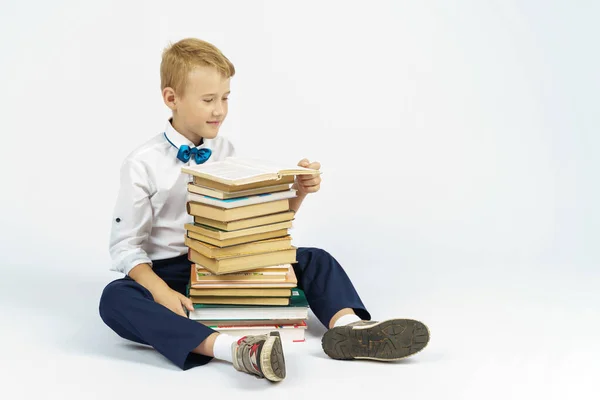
xmin=182 ymin=158 xmax=318 ymax=341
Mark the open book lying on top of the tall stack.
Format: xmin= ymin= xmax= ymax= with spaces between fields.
xmin=181 ymin=157 xmax=321 ymax=186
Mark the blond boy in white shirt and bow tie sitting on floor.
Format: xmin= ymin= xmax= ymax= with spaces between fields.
xmin=99 ymin=39 xmax=429 ymax=382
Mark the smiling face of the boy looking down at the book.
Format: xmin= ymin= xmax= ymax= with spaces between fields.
xmin=165 ymin=67 xmax=230 ymax=145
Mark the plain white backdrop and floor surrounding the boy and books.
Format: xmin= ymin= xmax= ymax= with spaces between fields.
xmin=0 ymin=0 xmax=600 ymax=399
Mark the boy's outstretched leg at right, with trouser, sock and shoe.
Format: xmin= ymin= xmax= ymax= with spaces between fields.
xmin=294 ymin=248 xmax=429 ymax=361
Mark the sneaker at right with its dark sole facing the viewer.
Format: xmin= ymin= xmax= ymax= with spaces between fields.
xmin=321 ymin=319 xmax=429 ymax=361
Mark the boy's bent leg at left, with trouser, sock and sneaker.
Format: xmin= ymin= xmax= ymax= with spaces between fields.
xmin=100 ymin=255 xmax=285 ymax=382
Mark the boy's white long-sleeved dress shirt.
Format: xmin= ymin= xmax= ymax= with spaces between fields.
xmin=109 ymin=121 xmax=235 ymax=275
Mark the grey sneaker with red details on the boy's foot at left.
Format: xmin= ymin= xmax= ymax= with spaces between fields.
xmin=231 ymin=332 xmax=285 ymax=382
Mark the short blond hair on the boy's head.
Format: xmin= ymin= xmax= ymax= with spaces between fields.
xmin=160 ymin=38 xmax=235 ymax=96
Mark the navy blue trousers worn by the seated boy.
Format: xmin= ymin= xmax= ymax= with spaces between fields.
xmin=99 ymin=247 xmax=371 ymax=370
